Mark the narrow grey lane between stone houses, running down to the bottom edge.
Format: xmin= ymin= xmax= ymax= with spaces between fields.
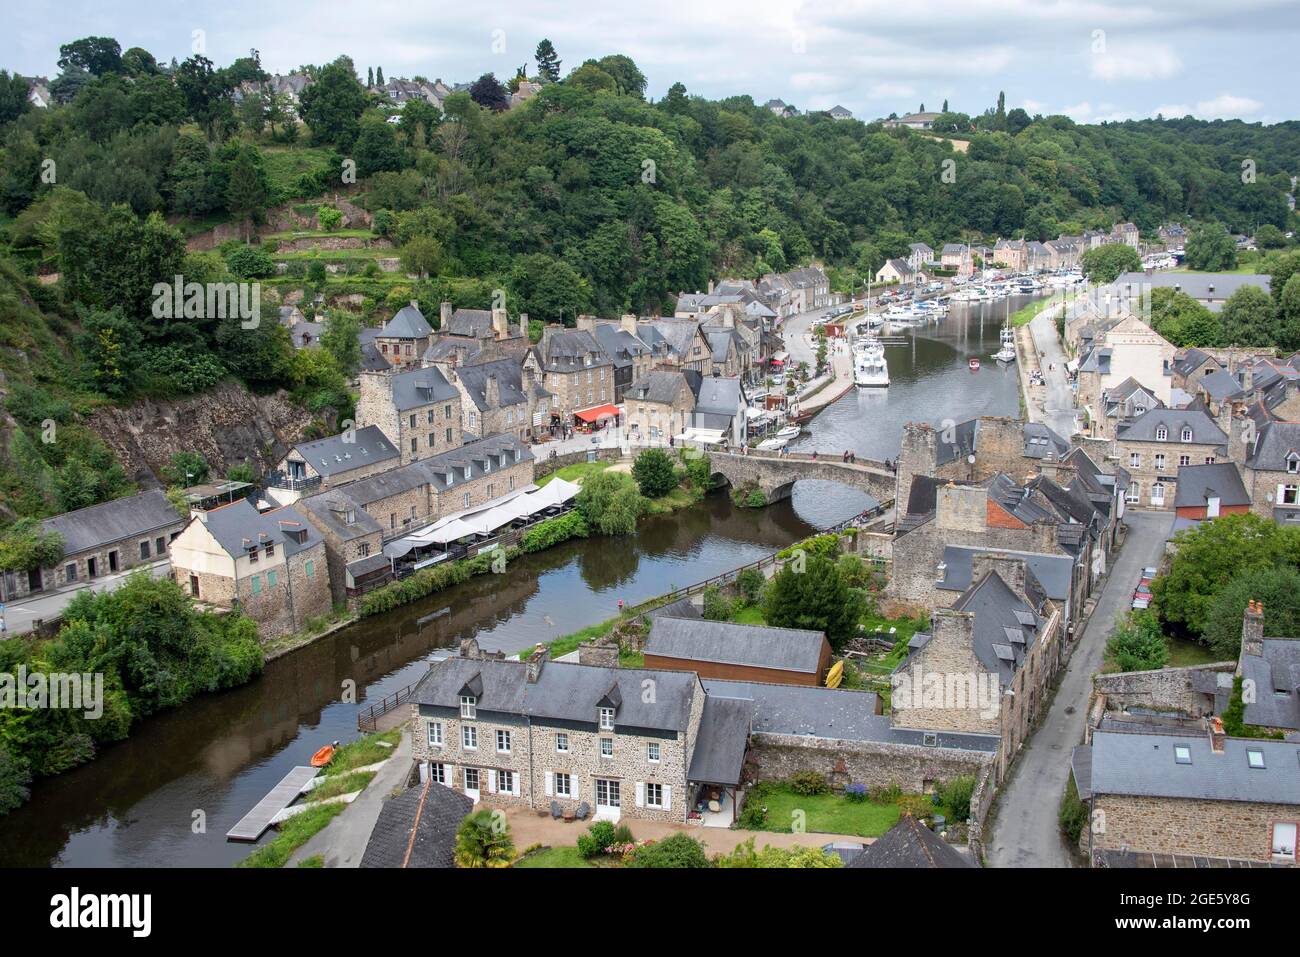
xmin=985 ymin=511 xmax=1174 ymax=867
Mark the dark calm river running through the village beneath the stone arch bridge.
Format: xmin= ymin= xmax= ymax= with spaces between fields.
xmin=0 ymin=293 xmax=1027 ymax=867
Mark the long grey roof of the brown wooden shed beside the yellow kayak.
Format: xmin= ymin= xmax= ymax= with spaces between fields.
xmin=644 ymin=616 xmax=826 ymax=675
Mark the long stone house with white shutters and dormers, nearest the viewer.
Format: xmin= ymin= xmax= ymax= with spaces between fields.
xmin=411 ymin=641 xmax=712 ymax=820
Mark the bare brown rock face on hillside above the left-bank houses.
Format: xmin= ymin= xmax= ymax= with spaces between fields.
xmin=87 ymin=382 xmax=312 ymax=488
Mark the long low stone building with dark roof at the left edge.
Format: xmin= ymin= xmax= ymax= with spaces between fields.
xmin=0 ymin=489 xmax=189 ymax=601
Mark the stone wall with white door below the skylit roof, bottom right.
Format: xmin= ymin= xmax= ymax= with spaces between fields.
xmin=1092 ymin=794 xmax=1300 ymax=861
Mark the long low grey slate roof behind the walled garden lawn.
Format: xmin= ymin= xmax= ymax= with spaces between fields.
xmin=701 ymin=677 xmax=998 ymax=754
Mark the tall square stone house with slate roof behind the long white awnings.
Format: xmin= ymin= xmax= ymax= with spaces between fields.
xmin=356 ymin=368 xmax=464 ymax=465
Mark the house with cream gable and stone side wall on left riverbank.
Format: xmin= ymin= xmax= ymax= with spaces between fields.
xmin=172 ymin=499 xmax=333 ymax=638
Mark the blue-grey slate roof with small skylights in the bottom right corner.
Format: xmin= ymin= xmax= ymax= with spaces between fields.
xmin=1091 ymin=731 xmax=1300 ymax=805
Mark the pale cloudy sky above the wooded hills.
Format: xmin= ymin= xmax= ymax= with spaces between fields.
xmin=0 ymin=0 xmax=1300 ymax=122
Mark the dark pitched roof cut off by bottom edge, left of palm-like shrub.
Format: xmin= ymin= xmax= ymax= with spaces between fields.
xmin=360 ymin=781 xmax=475 ymax=867
